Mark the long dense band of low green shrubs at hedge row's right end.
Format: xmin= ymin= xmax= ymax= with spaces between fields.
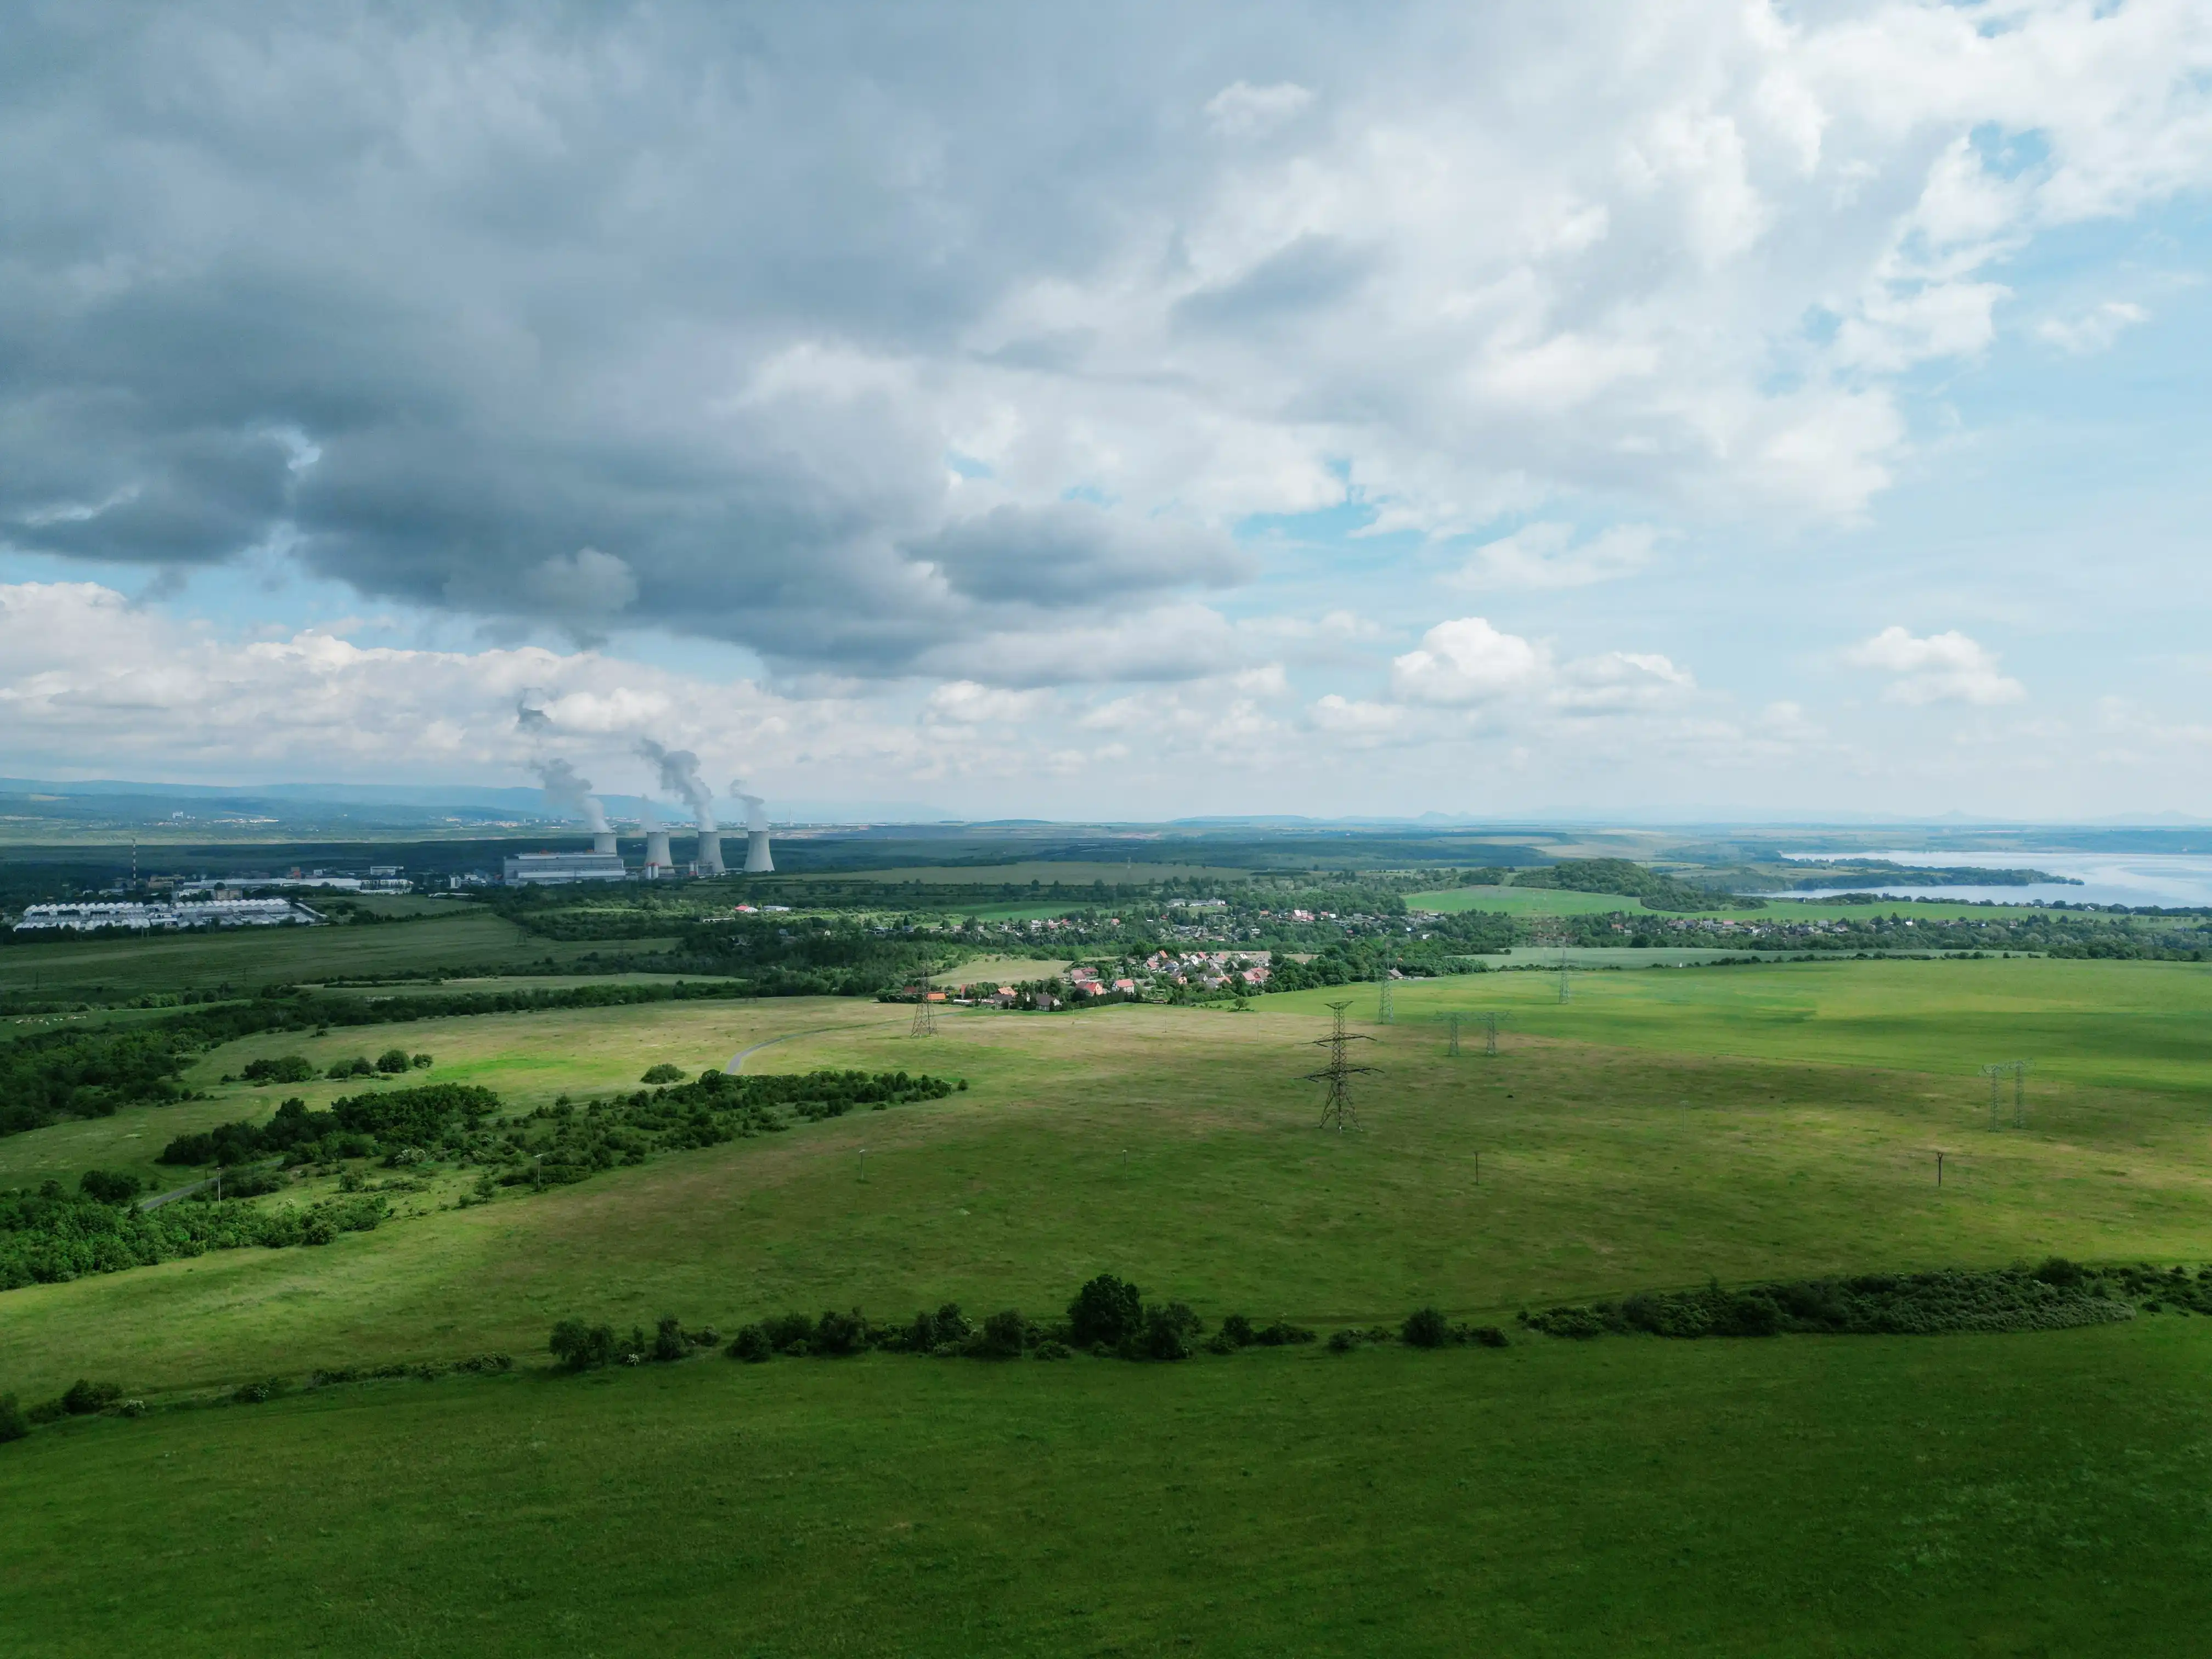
xmin=1520 ymin=1256 xmax=2141 ymax=1338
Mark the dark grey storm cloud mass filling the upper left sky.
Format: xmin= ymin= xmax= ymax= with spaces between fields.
xmin=0 ymin=2 xmax=1291 ymax=673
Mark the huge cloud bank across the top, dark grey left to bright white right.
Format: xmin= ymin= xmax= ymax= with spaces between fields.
xmin=0 ymin=0 xmax=2212 ymax=684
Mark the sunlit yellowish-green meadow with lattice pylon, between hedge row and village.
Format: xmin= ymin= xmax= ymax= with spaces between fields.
xmin=0 ymin=986 xmax=2212 ymax=1396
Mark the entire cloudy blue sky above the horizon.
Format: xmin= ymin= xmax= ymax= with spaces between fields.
xmin=0 ymin=0 xmax=2212 ymax=821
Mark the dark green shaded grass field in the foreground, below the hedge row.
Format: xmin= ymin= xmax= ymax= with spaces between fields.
xmin=0 ymin=1318 xmax=2212 ymax=1659
